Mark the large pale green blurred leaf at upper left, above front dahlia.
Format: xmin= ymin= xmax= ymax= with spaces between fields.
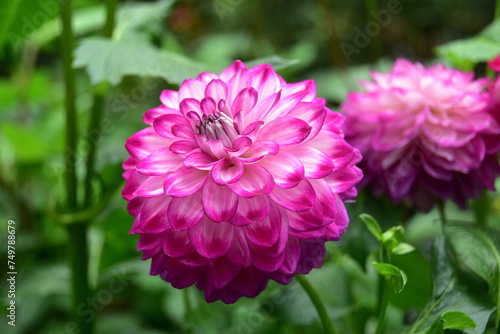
xmin=73 ymin=38 xmax=206 ymax=85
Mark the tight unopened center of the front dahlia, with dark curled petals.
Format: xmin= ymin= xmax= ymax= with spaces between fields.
xmin=196 ymin=111 xmax=238 ymax=147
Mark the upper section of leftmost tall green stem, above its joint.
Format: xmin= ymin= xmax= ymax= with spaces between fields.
xmin=61 ymin=0 xmax=78 ymax=211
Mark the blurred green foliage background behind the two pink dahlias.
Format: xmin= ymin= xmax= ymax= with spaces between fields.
xmin=0 ymin=0 xmax=500 ymax=334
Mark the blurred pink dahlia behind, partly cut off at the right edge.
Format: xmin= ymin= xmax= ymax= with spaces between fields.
xmin=341 ymin=59 xmax=500 ymax=211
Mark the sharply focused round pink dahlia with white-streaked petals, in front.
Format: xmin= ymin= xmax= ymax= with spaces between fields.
xmin=122 ymin=61 xmax=362 ymax=303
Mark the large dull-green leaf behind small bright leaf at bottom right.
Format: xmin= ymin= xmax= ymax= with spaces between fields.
xmin=410 ymin=239 xmax=495 ymax=334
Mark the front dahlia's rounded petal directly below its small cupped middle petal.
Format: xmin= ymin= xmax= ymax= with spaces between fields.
xmin=201 ymin=179 xmax=238 ymax=223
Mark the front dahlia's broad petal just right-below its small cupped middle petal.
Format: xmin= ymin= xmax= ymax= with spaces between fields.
xmin=227 ymin=165 xmax=274 ymax=197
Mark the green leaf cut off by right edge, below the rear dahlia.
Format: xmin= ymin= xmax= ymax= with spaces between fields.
xmin=444 ymin=224 xmax=500 ymax=327
